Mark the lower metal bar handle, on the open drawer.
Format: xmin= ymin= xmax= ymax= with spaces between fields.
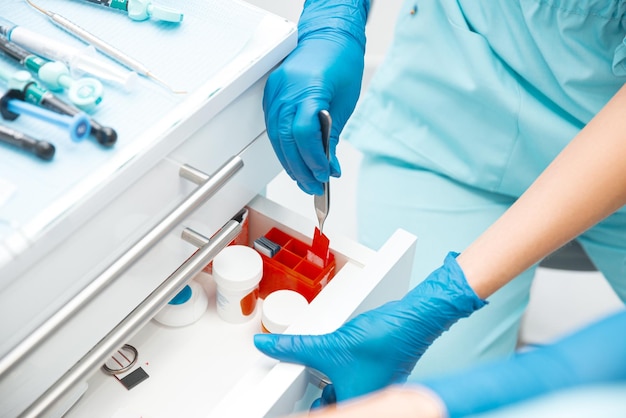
xmin=21 ymin=220 xmax=242 ymax=418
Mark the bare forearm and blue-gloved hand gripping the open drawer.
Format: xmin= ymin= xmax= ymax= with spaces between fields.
xmin=255 ymin=83 xmax=626 ymax=414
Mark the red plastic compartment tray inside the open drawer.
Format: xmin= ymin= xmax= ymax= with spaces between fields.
xmin=259 ymin=228 xmax=336 ymax=302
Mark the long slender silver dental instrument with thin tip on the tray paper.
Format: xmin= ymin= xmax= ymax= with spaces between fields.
xmin=25 ymin=0 xmax=187 ymax=94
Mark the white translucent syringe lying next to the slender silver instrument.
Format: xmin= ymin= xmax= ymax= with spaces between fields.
xmin=0 ymin=18 xmax=137 ymax=90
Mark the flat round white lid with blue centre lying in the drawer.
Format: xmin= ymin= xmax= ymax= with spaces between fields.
xmin=154 ymin=280 xmax=209 ymax=327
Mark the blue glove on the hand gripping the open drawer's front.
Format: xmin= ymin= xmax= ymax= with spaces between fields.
xmin=254 ymin=253 xmax=486 ymax=401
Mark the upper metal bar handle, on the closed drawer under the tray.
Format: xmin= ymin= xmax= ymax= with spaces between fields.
xmin=0 ymin=155 xmax=243 ymax=379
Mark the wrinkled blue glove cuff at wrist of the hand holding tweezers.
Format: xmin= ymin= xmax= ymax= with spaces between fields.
xmin=298 ymin=0 xmax=370 ymax=51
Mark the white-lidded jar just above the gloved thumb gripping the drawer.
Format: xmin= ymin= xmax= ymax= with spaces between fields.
xmin=261 ymin=290 xmax=309 ymax=334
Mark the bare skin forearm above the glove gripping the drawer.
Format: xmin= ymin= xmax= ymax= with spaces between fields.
xmin=457 ymin=82 xmax=626 ymax=298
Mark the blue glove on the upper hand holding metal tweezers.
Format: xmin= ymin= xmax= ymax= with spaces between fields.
xmin=263 ymin=0 xmax=369 ymax=194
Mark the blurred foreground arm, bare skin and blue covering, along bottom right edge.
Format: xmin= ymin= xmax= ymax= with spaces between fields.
xmin=290 ymin=311 xmax=626 ymax=418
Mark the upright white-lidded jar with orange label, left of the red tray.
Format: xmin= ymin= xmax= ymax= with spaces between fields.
xmin=208 ymin=245 xmax=263 ymax=323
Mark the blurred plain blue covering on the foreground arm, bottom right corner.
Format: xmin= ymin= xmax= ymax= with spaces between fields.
xmin=422 ymin=311 xmax=626 ymax=418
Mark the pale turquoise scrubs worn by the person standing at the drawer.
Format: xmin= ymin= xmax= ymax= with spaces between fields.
xmin=343 ymin=0 xmax=626 ymax=377
